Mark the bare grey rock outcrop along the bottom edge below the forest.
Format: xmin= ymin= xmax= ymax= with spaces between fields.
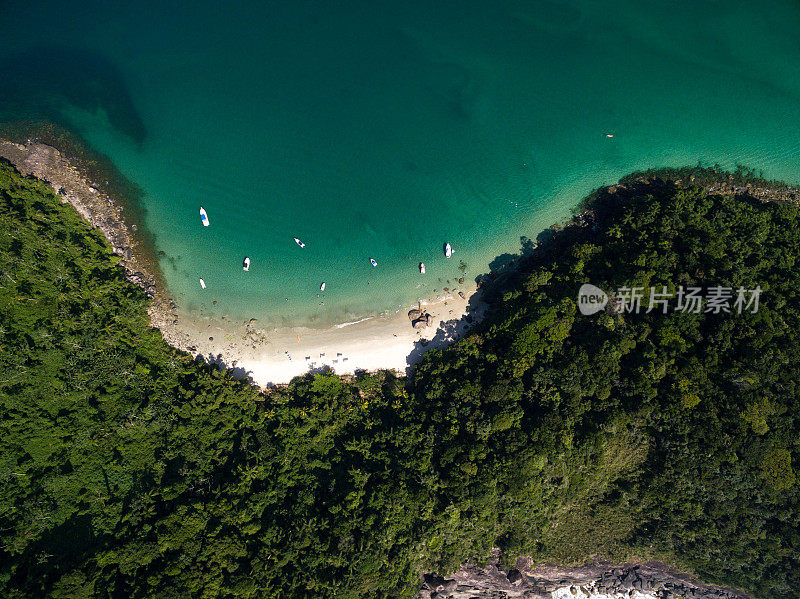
xmin=419 ymin=558 xmax=751 ymax=599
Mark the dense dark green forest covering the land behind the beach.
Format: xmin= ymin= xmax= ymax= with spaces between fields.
xmin=0 ymin=163 xmax=800 ymax=599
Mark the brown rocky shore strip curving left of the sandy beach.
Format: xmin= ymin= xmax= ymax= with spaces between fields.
xmin=0 ymin=140 xmax=180 ymax=340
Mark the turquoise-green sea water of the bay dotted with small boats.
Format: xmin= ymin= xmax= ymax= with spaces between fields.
xmin=0 ymin=0 xmax=800 ymax=324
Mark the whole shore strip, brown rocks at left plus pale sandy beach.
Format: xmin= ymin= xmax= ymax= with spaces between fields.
xmin=0 ymin=139 xmax=488 ymax=388
